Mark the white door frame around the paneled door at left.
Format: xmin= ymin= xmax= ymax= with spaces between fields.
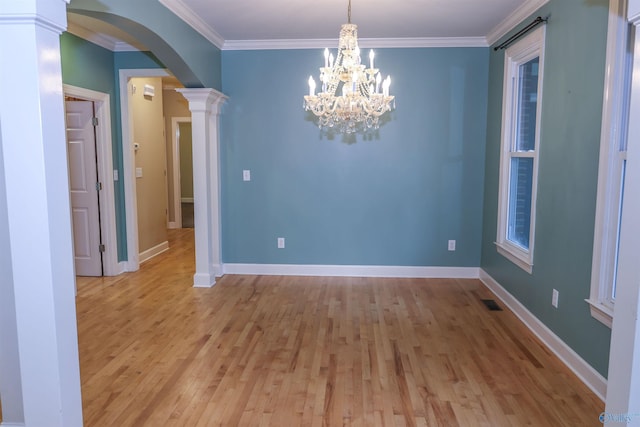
xmin=63 ymin=84 xmax=120 ymax=276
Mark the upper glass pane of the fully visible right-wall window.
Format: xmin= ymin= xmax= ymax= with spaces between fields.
xmin=515 ymin=57 xmax=540 ymax=151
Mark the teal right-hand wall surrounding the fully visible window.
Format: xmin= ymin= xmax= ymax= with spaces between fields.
xmin=482 ymin=0 xmax=610 ymax=376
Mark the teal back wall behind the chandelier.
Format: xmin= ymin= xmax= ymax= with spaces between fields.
xmin=221 ymin=48 xmax=489 ymax=267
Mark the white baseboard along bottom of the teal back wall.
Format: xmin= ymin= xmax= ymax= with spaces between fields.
xmin=223 ymin=264 xmax=480 ymax=279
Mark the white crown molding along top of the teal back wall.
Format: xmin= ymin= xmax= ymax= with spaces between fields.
xmin=222 ymin=37 xmax=489 ymax=50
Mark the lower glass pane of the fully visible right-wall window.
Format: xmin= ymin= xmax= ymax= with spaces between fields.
xmin=507 ymin=157 xmax=533 ymax=250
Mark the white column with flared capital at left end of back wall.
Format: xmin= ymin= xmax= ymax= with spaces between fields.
xmin=176 ymin=88 xmax=227 ymax=287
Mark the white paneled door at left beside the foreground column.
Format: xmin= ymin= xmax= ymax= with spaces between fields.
xmin=65 ymin=101 xmax=102 ymax=276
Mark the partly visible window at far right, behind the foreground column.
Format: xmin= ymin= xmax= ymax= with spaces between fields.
xmin=586 ymin=0 xmax=633 ymax=327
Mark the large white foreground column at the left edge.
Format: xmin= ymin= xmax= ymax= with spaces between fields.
xmin=0 ymin=0 xmax=82 ymax=427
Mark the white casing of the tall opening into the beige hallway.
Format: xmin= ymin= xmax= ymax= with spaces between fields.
xmin=118 ymin=68 xmax=170 ymax=271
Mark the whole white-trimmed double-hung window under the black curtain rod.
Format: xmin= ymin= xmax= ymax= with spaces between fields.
xmin=496 ymin=26 xmax=545 ymax=273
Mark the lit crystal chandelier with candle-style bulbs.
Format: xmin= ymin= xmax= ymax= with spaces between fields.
xmin=304 ymin=0 xmax=395 ymax=133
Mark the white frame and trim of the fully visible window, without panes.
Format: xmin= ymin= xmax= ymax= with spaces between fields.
xmin=495 ymin=26 xmax=546 ymax=274
